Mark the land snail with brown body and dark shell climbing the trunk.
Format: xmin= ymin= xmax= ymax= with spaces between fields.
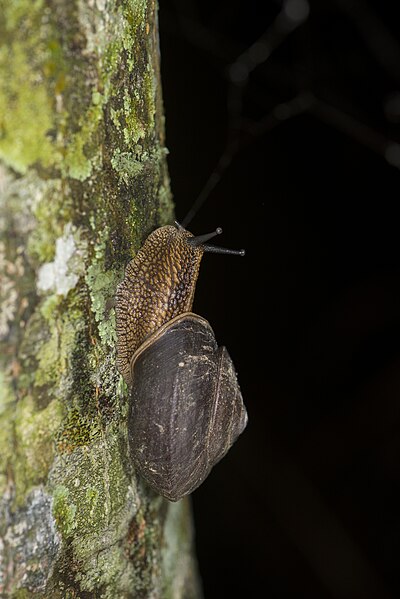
xmin=115 ymin=223 xmax=247 ymax=501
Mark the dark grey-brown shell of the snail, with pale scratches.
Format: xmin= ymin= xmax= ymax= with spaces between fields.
xmin=128 ymin=312 xmax=247 ymax=501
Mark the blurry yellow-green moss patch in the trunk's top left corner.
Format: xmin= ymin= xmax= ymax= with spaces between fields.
xmin=0 ymin=0 xmax=104 ymax=181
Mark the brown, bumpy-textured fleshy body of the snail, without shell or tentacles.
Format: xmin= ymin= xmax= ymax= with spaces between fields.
xmin=115 ymin=225 xmax=204 ymax=384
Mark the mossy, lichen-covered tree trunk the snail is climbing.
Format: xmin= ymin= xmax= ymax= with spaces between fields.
xmin=0 ymin=0 xmax=200 ymax=599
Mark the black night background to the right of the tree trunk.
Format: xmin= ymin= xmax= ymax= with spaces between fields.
xmin=159 ymin=0 xmax=400 ymax=599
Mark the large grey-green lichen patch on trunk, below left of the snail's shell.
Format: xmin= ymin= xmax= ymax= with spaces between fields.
xmin=50 ymin=424 xmax=137 ymax=597
